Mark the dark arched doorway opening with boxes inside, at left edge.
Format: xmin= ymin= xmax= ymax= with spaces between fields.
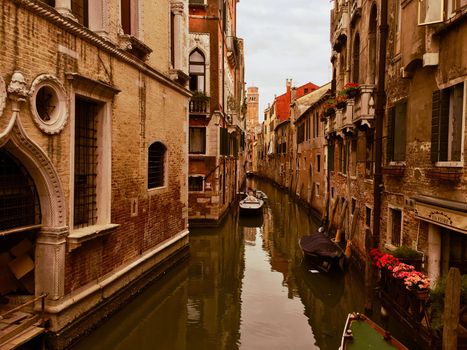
xmin=0 ymin=148 xmax=41 ymax=297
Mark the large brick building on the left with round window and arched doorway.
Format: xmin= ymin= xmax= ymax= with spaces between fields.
xmin=0 ymin=0 xmax=190 ymax=347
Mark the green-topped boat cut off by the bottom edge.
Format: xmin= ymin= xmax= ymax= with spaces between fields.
xmin=339 ymin=313 xmax=408 ymax=350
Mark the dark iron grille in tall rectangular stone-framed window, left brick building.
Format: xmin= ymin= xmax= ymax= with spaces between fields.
xmin=73 ymin=99 xmax=99 ymax=228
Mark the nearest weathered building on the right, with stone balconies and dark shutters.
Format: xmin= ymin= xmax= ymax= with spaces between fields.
xmin=327 ymin=0 xmax=467 ymax=281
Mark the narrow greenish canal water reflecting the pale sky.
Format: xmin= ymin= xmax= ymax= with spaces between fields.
xmin=73 ymin=182 xmax=414 ymax=350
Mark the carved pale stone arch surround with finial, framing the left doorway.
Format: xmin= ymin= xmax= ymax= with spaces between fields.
xmin=0 ymin=72 xmax=68 ymax=300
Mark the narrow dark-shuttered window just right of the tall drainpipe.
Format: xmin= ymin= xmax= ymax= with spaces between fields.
xmin=386 ymin=101 xmax=407 ymax=162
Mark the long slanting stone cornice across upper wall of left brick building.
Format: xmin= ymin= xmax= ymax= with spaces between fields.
xmin=13 ymin=0 xmax=191 ymax=97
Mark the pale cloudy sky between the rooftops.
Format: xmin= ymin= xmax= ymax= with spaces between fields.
xmin=237 ymin=0 xmax=331 ymax=120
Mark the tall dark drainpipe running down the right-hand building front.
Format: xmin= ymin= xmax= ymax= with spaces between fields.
xmin=373 ymin=0 xmax=388 ymax=247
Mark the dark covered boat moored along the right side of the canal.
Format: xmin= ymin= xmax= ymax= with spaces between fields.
xmin=298 ymin=228 xmax=345 ymax=272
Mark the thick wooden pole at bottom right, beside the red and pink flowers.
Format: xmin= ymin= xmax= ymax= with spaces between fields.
xmin=443 ymin=267 xmax=461 ymax=350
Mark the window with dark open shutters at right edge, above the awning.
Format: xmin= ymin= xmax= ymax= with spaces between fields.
xmin=431 ymin=83 xmax=464 ymax=162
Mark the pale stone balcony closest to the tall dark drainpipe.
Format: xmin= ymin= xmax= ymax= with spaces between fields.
xmin=347 ymin=85 xmax=376 ymax=124
